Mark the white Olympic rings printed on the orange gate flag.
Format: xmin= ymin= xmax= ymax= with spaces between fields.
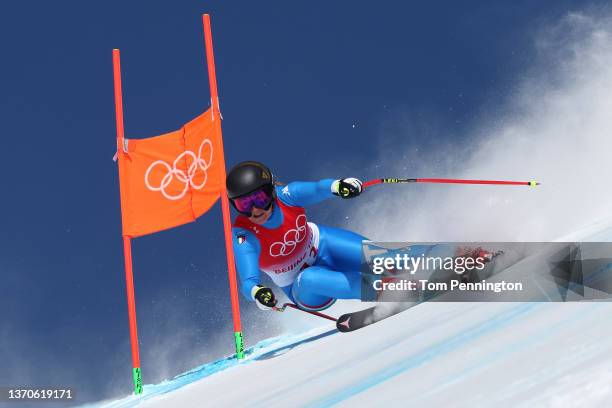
xmin=145 ymin=139 xmax=213 ymax=200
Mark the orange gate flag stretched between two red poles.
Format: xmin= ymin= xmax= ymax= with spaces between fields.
xmin=119 ymin=109 xmax=224 ymax=237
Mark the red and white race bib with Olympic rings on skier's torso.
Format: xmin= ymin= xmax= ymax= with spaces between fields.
xmin=234 ymin=200 xmax=319 ymax=287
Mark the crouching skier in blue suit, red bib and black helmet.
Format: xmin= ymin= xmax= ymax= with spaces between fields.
xmin=226 ymin=161 xmax=366 ymax=311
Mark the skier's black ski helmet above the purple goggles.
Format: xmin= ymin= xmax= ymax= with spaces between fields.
xmin=225 ymin=161 xmax=274 ymax=200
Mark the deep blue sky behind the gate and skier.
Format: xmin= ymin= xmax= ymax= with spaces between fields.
xmin=0 ymin=1 xmax=603 ymax=402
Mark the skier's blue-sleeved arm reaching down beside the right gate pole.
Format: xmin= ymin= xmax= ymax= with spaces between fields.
xmin=232 ymin=228 xmax=261 ymax=300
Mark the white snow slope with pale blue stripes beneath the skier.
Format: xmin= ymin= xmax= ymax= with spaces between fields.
xmin=87 ymin=220 xmax=612 ymax=407
